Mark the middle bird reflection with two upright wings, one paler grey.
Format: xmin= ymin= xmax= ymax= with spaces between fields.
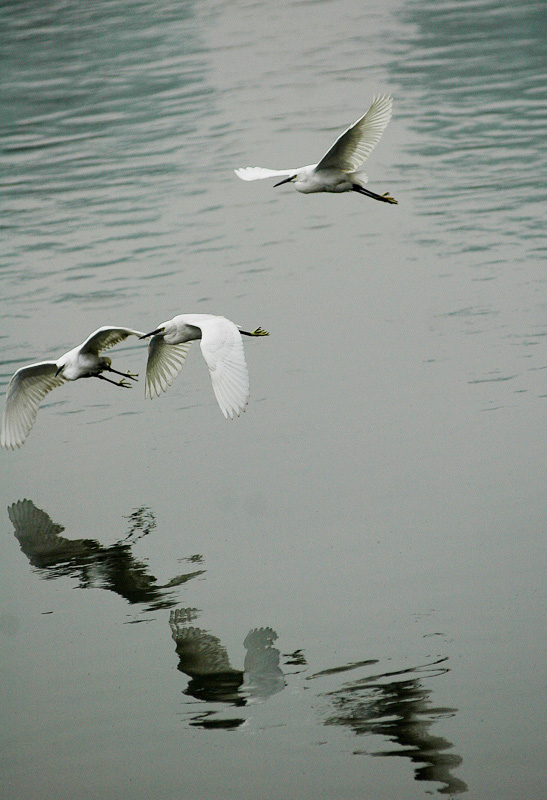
xmin=169 ymin=609 xmax=285 ymax=730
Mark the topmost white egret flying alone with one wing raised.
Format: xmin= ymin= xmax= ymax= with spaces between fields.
xmin=234 ymin=94 xmax=397 ymax=203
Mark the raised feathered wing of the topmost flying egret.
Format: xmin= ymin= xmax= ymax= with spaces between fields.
xmin=316 ymin=94 xmax=393 ymax=172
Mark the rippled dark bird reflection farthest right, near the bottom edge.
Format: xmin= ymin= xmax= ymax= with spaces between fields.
xmin=309 ymin=658 xmax=467 ymax=795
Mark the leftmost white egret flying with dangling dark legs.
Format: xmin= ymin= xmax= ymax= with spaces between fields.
xmin=0 ymin=326 xmax=142 ymax=450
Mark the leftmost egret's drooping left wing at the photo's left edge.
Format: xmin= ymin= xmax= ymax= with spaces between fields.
xmin=0 ymin=361 xmax=66 ymax=450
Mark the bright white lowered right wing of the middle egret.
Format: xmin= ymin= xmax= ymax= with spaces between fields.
xmin=200 ymin=317 xmax=249 ymax=419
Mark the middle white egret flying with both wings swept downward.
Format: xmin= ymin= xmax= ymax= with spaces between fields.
xmin=141 ymin=314 xmax=269 ymax=419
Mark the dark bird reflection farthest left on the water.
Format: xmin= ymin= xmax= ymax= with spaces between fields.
xmin=8 ymin=500 xmax=205 ymax=610
